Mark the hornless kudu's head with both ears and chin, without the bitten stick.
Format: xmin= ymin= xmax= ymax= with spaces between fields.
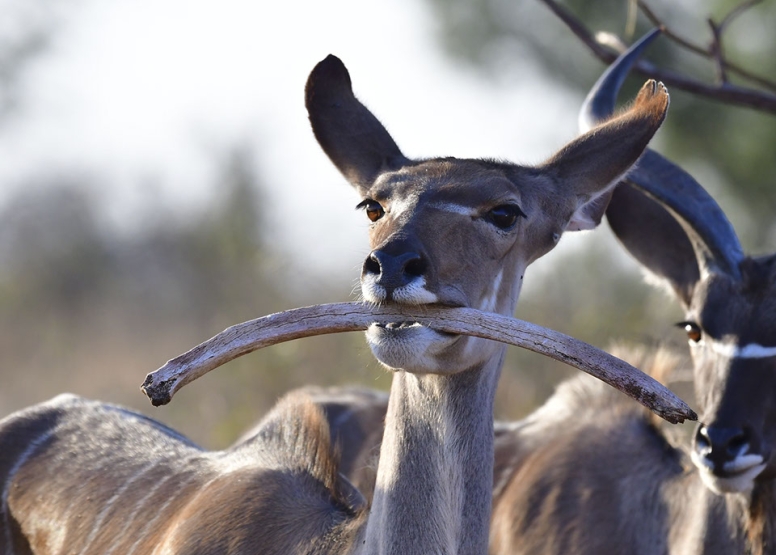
xmin=306 ymin=56 xmax=668 ymax=373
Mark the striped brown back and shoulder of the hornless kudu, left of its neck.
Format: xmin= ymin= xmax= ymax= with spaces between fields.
xmin=0 ymin=395 xmax=365 ymax=555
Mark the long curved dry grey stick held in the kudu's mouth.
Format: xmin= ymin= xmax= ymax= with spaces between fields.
xmin=141 ymin=303 xmax=697 ymax=423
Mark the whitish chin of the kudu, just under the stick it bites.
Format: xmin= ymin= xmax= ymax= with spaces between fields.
xmin=366 ymin=323 xmax=458 ymax=373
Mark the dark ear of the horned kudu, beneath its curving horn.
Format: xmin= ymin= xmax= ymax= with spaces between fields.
xmin=606 ymin=182 xmax=700 ymax=308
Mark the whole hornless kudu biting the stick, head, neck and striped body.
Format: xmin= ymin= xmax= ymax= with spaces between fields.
xmin=0 ymin=56 xmax=668 ymax=555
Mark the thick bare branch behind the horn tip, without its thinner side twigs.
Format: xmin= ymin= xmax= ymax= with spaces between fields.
xmin=541 ymin=0 xmax=776 ymax=114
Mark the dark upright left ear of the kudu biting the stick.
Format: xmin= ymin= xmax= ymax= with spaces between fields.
xmin=305 ymin=54 xmax=408 ymax=189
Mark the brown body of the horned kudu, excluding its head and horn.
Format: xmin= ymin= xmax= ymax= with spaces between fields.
xmin=490 ymin=349 xmax=776 ymax=555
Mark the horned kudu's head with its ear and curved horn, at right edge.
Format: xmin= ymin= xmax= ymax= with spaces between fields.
xmin=580 ymin=32 xmax=776 ymax=493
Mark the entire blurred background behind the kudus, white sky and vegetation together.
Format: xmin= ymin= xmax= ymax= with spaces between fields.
xmin=0 ymin=0 xmax=776 ymax=448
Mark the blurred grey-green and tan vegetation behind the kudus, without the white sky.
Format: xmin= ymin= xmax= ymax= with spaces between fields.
xmin=0 ymin=0 xmax=776 ymax=447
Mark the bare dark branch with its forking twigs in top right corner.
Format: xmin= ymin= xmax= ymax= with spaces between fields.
xmin=541 ymin=0 xmax=776 ymax=114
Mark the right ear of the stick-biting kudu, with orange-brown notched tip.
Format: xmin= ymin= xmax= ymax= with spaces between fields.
xmin=542 ymin=80 xmax=669 ymax=231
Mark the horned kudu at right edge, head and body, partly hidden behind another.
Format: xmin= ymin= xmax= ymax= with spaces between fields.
xmin=491 ymin=30 xmax=776 ymax=555
